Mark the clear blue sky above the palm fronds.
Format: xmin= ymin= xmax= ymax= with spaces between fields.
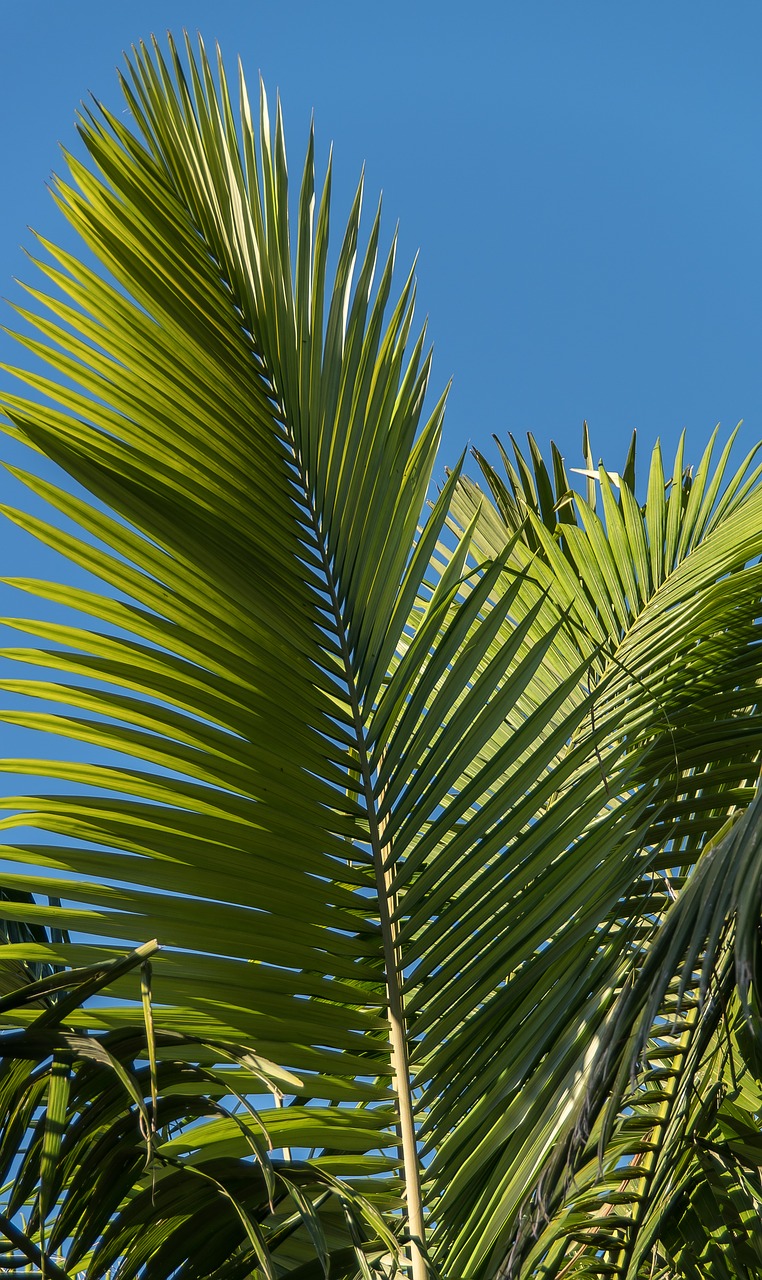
xmin=0 ymin=0 xmax=762 ymax=481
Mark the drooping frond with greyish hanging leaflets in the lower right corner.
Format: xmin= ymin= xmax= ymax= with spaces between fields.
xmin=521 ymin=795 xmax=762 ymax=1280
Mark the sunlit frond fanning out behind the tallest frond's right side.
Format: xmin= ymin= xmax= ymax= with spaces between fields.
xmin=437 ymin=435 xmax=761 ymax=1275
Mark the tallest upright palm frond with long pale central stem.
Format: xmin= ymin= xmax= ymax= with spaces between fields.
xmin=1 ymin=30 xmax=596 ymax=1275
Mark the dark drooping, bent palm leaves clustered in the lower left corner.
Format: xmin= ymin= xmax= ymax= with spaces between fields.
xmin=0 ymin=942 xmax=394 ymax=1280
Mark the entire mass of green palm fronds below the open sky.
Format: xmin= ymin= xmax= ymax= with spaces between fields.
xmin=0 ymin=30 xmax=762 ymax=1280
